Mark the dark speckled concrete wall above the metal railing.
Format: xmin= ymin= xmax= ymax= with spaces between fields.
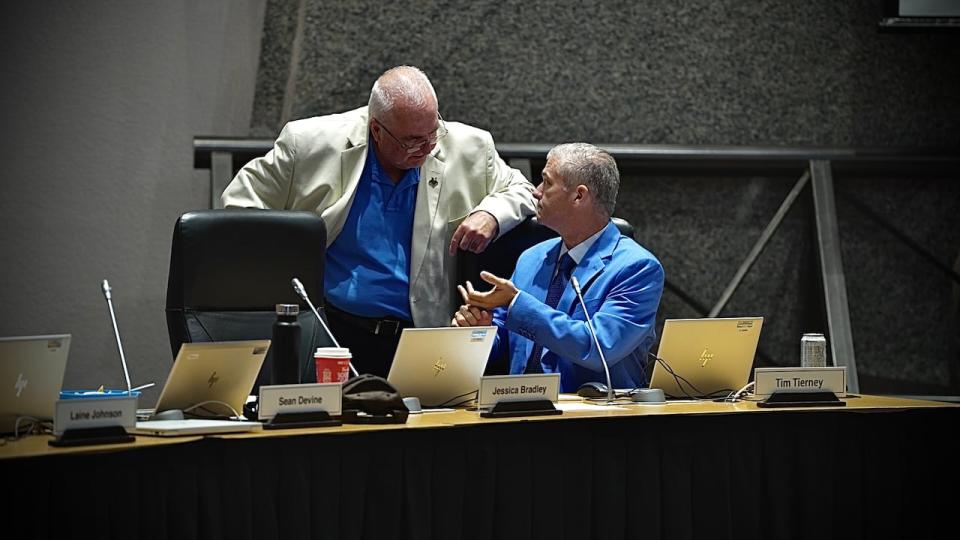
xmin=253 ymin=0 xmax=960 ymax=147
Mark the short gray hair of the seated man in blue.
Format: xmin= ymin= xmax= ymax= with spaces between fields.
xmin=547 ymin=143 xmax=620 ymax=218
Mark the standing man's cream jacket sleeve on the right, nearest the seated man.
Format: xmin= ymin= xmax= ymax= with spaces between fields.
xmin=473 ymin=135 xmax=535 ymax=238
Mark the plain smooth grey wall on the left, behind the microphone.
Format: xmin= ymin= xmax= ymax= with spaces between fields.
xmin=0 ymin=0 xmax=265 ymax=405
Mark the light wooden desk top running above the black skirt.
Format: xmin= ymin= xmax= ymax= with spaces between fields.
xmin=0 ymin=394 xmax=960 ymax=460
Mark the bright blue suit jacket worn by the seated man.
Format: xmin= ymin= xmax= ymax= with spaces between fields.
xmin=491 ymin=222 xmax=663 ymax=392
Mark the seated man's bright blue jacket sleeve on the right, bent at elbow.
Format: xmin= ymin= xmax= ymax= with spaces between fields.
xmin=506 ymin=258 xmax=664 ymax=370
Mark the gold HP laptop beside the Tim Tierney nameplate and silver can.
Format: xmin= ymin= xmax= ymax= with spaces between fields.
xmin=650 ymin=317 xmax=763 ymax=399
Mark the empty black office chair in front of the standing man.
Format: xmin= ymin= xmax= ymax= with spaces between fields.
xmin=167 ymin=209 xmax=333 ymax=393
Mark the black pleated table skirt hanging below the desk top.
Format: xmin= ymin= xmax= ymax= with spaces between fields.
xmin=0 ymin=409 xmax=960 ymax=540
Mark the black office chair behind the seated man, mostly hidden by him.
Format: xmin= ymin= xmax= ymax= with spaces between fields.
xmin=457 ymin=217 xmax=634 ymax=375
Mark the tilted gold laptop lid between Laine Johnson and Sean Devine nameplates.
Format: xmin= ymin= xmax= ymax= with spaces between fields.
xmin=156 ymin=339 xmax=270 ymax=416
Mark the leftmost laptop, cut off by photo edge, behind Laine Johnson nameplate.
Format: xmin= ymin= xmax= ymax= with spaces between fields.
xmin=0 ymin=334 xmax=70 ymax=433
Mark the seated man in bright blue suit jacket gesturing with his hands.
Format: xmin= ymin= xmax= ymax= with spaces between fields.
xmin=452 ymin=143 xmax=663 ymax=392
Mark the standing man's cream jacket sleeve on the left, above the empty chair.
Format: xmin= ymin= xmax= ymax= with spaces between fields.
xmin=220 ymin=125 xmax=296 ymax=210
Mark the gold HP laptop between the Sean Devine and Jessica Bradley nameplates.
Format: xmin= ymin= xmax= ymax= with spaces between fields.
xmin=387 ymin=326 xmax=497 ymax=407
